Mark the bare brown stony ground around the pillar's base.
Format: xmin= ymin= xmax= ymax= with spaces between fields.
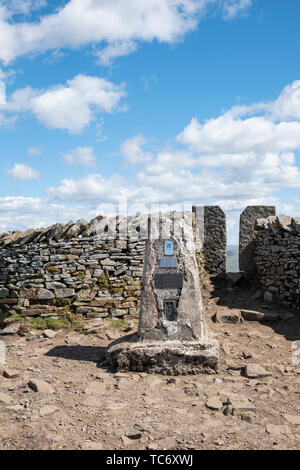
xmin=0 ymin=279 xmax=300 ymax=450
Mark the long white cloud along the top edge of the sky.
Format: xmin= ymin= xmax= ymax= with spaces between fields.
xmin=0 ymin=0 xmax=251 ymax=63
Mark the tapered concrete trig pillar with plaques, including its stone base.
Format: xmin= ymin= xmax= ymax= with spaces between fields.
xmin=107 ymin=212 xmax=219 ymax=375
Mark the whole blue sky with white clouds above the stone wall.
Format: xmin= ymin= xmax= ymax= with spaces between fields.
xmin=0 ymin=0 xmax=300 ymax=243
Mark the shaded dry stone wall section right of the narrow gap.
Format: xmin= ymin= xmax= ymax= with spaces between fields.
xmin=254 ymin=216 xmax=300 ymax=310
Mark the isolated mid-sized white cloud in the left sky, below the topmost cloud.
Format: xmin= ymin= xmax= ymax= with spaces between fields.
xmin=0 ymin=74 xmax=126 ymax=134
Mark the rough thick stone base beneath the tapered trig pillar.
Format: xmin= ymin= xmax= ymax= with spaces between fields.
xmin=106 ymin=334 xmax=219 ymax=375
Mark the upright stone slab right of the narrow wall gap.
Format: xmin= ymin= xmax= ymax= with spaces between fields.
xmin=239 ymin=206 xmax=276 ymax=272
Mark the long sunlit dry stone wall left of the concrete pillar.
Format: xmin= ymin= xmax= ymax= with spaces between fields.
xmin=0 ymin=218 xmax=145 ymax=318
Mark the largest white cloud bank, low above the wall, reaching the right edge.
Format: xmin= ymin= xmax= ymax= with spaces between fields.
xmin=45 ymin=82 xmax=300 ymax=213
